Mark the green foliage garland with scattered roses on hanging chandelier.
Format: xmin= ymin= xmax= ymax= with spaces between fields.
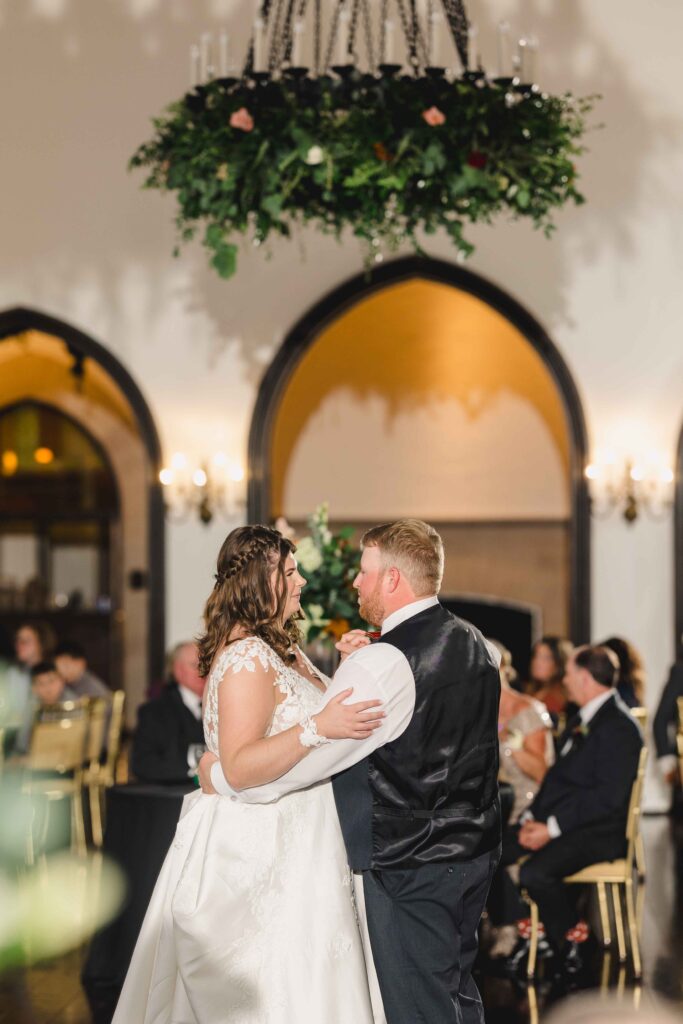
xmin=130 ymin=70 xmax=595 ymax=278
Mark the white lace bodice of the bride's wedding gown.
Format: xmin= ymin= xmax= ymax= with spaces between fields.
xmin=204 ymin=636 xmax=329 ymax=756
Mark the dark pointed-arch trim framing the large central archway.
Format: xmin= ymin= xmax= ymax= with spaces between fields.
xmin=247 ymin=256 xmax=591 ymax=643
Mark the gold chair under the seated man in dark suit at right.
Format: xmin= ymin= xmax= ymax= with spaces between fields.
xmin=522 ymin=746 xmax=647 ymax=978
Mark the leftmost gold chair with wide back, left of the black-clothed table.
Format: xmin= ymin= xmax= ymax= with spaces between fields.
xmin=23 ymin=698 xmax=88 ymax=863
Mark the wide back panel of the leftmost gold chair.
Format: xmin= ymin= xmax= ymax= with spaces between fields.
xmin=26 ymin=700 xmax=88 ymax=774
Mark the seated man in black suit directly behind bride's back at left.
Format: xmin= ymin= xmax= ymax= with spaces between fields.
xmin=130 ymin=643 xmax=205 ymax=784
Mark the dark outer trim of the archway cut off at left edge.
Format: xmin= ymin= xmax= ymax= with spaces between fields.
xmin=0 ymin=306 xmax=166 ymax=679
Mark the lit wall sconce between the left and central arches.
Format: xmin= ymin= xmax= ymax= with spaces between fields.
xmin=159 ymin=452 xmax=245 ymax=524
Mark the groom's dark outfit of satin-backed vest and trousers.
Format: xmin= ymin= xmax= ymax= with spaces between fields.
xmin=333 ymin=604 xmax=501 ymax=1024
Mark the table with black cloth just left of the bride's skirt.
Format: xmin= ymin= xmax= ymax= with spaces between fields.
xmin=81 ymin=783 xmax=191 ymax=1024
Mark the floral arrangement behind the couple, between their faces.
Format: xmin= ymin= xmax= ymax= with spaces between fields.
xmin=282 ymin=502 xmax=364 ymax=643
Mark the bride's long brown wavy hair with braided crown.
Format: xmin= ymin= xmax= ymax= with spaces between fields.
xmin=197 ymin=526 xmax=300 ymax=677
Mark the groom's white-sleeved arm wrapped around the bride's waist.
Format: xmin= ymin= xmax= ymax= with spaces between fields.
xmin=211 ymin=643 xmax=415 ymax=804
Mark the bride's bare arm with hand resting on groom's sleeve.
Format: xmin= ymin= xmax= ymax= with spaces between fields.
xmin=218 ymin=663 xmax=381 ymax=791
